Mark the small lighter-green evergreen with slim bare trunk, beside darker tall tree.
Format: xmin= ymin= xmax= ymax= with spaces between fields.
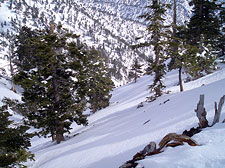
xmin=168 ymin=26 xmax=202 ymax=80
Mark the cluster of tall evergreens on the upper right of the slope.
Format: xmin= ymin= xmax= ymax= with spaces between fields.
xmin=134 ymin=0 xmax=224 ymax=101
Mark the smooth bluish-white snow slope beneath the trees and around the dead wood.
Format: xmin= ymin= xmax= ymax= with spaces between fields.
xmin=0 ymin=63 xmax=225 ymax=168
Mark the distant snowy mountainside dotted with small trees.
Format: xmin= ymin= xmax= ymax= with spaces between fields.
xmin=0 ymin=0 xmax=190 ymax=84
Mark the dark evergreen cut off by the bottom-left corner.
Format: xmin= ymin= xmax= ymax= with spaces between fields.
xmin=0 ymin=99 xmax=34 ymax=167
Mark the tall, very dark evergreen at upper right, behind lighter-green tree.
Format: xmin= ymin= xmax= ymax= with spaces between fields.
xmin=187 ymin=0 xmax=220 ymax=74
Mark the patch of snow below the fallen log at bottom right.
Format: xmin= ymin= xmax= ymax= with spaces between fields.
xmin=140 ymin=124 xmax=225 ymax=168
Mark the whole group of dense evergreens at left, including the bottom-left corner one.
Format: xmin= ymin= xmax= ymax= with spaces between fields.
xmin=0 ymin=23 xmax=113 ymax=166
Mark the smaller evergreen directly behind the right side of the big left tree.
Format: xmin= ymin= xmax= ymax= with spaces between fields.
xmin=87 ymin=49 xmax=114 ymax=112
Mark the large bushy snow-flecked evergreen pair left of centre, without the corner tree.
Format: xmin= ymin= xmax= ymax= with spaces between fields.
xmin=15 ymin=25 xmax=113 ymax=143
